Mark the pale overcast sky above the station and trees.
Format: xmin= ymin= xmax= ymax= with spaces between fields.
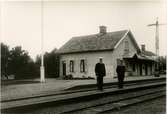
xmin=0 ymin=0 xmax=167 ymax=59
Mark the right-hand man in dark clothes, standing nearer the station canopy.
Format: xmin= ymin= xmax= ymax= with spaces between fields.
xmin=116 ymin=61 xmax=125 ymax=88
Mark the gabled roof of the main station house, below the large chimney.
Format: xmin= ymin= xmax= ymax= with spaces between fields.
xmin=58 ymin=30 xmax=140 ymax=54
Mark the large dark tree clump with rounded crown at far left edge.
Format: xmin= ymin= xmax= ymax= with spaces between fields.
xmin=1 ymin=43 xmax=37 ymax=79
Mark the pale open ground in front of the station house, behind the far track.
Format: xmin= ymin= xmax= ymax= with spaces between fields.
xmin=1 ymin=75 xmax=166 ymax=101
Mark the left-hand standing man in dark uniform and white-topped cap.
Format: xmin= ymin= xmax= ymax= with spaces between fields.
xmin=95 ymin=57 xmax=106 ymax=91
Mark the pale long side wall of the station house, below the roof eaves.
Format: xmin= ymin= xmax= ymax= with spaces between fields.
xmin=60 ymin=51 xmax=112 ymax=77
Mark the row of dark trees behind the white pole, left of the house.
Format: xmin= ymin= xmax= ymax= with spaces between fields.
xmin=1 ymin=43 xmax=59 ymax=79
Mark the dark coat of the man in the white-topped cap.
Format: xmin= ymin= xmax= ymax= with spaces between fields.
xmin=95 ymin=63 xmax=106 ymax=77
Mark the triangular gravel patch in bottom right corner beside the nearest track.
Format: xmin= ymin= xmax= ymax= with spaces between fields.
xmin=108 ymin=97 xmax=166 ymax=114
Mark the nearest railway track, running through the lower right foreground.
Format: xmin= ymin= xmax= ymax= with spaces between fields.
xmin=63 ymin=87 xmax=165 ymax=114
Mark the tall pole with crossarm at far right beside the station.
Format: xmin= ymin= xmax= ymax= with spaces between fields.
xmin=148 ymin=17 xmax=166 ymax=76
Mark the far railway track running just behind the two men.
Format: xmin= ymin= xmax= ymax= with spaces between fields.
xmin=1 ymin=77 xmax=166 ymax=103
